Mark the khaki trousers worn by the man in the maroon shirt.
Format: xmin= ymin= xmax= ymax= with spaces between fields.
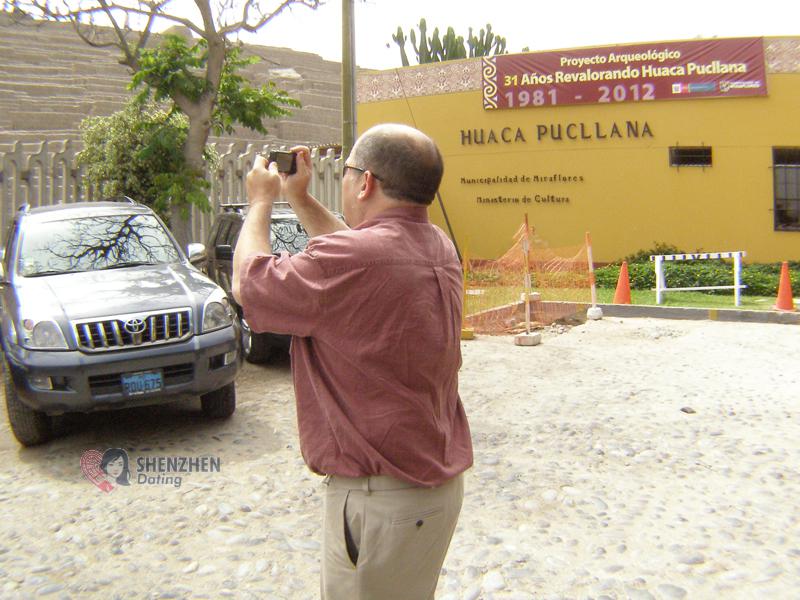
xmin=321 ymin=475 xmax=464 ymax=600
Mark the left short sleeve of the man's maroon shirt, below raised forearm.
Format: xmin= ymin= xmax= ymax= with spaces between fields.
xmin=239 ymin=252 xmax=325 ymax=337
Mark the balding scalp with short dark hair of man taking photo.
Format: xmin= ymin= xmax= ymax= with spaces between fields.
xmin=351 ymin=123 xmax=444 ymax=206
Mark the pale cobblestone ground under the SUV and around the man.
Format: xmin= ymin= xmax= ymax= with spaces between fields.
xmin=0 ymin=318 xmax=800 ymax=600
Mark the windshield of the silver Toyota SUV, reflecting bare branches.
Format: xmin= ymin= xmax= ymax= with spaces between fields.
xmin=17 ymin=214 xmax=179 ymax=277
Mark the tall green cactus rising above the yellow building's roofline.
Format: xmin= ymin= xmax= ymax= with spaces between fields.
xmin=387 ymin=19 xmax=506 ymax=67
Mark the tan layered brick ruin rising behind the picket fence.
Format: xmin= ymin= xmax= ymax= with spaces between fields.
xmin=0 ymin=13 xmax=341 ymax=152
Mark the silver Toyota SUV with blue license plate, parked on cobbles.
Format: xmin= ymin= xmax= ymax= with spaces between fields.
xmin=0 ymin=198 xmax=241 ymax=446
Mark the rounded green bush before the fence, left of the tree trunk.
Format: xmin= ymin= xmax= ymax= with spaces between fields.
xmin=78 ymin=99 xmax=218 ymax=221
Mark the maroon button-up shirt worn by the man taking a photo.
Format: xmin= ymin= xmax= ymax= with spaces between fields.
xmin=239 ymin=206 xmax=472 ymax=486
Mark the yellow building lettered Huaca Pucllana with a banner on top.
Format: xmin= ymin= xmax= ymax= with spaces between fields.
xmin=358 ymin=38 xmax=800 ymax=263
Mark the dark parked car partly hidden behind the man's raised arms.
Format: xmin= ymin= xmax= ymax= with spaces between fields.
xmin=204 ymin=203 xmax=308 ymax=363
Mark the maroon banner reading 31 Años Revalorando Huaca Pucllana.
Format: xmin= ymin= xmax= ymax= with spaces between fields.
xmin=483 ymin=38 xmax=767 ymax=110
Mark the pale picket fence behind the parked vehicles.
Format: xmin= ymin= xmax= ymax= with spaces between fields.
xmin=0 ymin=140 xmax=344 ymax=242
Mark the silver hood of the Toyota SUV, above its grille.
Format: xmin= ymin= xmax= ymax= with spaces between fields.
xmin=17 ymin=263 xmax=217 ymax=321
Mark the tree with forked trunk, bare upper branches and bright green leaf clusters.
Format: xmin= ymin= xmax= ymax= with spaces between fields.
xmin=4 ymin=0 xmax=320 ymax=245
